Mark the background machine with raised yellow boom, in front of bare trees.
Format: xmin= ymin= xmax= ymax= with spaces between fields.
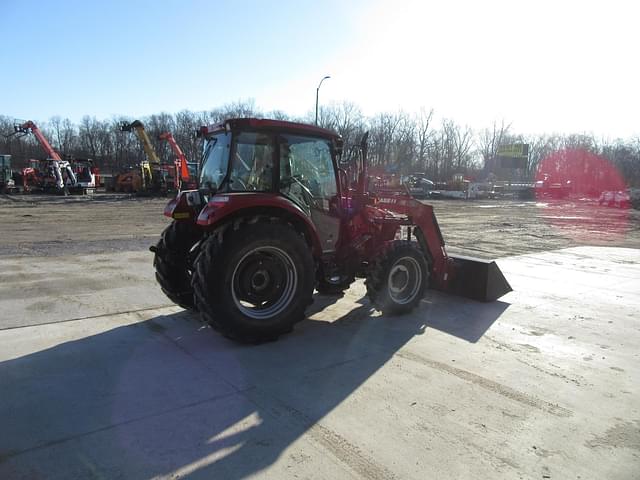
xmin=115 ymin=120 xmax=167 ymax=195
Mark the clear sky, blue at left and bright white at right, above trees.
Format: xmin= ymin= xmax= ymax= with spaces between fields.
xmin=0 ymin=0 xmax=640 ymax=138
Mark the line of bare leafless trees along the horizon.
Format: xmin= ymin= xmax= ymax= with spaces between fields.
xmin=0 ymin=100 xmax=640 ymax=187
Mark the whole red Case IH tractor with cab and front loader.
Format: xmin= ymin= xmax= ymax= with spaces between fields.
xmin=151 ymin=118 xmax=511 ymax=343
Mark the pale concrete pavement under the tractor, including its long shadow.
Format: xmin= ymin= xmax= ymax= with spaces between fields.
xmin=0 ymin=247 xmax=640 ymax=479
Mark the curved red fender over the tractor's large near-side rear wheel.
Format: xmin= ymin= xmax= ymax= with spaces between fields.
xmin=197 ymin=192 xmax=322 ymax=256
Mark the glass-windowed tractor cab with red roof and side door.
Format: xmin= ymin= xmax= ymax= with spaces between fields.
xmin=188 ymin=119 xmax=342 ymax=252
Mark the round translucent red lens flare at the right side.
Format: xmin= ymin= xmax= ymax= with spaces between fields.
xmin=535 ymin=148 xmax=630 ymax=244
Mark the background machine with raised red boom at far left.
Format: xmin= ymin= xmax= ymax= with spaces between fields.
xmin=13 ymin=120 xmax=78 ymax=195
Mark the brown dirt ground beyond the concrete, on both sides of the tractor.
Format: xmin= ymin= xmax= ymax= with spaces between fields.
xmin=0 ymin=194 xmax=640 ymax=259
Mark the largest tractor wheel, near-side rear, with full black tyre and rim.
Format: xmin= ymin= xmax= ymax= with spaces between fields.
xmin=193 ymin=222 xmax=315 ymax=343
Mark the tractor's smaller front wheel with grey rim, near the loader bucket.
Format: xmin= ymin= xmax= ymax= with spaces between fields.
xmin=365 ymin=240 xmax=429 ymax=315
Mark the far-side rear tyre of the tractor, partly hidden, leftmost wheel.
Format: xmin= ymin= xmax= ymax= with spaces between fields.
xmin=151 ymin=222 xmax=202 ymax=310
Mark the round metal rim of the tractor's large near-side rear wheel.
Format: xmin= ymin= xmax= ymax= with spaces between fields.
xmin=231 ymin=246 xmax=298 ymax=320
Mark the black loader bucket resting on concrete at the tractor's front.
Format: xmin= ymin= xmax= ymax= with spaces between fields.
xmin=444 ymin=256 xmax=512 ymax=302
